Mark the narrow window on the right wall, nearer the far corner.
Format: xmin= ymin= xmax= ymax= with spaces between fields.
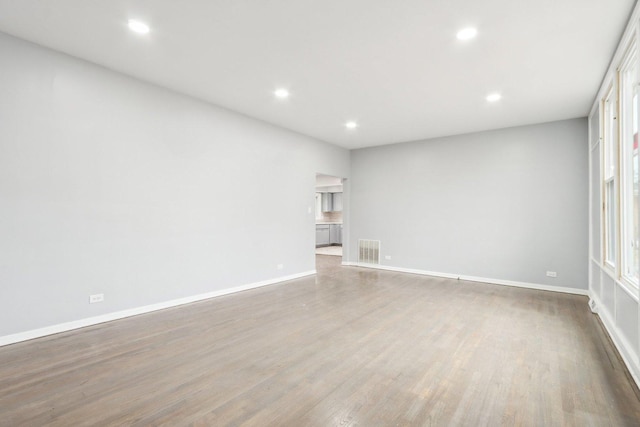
xmin=602 ymin=86 xmax=617 ymax=269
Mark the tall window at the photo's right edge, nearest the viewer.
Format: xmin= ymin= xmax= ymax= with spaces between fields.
xmin=620 ymin=44 xmax=639 ymax=286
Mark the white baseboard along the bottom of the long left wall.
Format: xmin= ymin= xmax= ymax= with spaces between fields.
xmin=0 ymin=270 xmax=316 ymax=347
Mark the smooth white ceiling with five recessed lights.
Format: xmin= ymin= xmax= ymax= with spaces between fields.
xmin=0 ymin=0 xmax=635 ymax=148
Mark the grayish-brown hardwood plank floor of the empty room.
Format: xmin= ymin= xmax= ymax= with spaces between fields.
xmin=0 ymin=256 xmax=640 ymax=426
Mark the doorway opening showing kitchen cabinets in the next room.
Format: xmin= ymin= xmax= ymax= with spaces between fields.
xmin=315 ymin=174 xmax=344 ymax=264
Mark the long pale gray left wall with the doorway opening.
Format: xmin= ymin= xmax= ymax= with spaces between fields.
xmin=0 ymin=34 xmax=349 ymax=342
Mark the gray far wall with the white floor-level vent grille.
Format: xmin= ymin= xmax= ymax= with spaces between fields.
xmin=349 ymin=118 xmax=589 ymax=290
